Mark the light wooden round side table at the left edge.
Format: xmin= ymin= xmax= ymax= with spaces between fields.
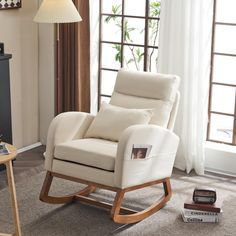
xmin=0 ymin=144 xmax=21 ymax=236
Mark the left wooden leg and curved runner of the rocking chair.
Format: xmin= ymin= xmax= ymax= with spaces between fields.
xmin=39 ymin=171 xmax=96 ymax=204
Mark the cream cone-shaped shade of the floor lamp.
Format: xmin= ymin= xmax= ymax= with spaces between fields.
xmin=34 ymin=0 xmax=82 ymax=23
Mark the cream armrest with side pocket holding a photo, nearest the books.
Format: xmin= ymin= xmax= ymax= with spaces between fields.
xmin=115 ymin=125 xmax=179 ymax=188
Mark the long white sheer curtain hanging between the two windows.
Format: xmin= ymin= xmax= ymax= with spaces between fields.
xmin=159 ymin=0 xmax=213 ymax=174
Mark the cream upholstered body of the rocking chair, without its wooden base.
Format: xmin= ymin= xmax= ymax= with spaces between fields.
xmin=45 ymin=70 xmax=179 ymax=188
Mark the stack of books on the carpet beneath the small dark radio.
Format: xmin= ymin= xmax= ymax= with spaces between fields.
xmin=181 ymin=200 xmax=222 ymax=223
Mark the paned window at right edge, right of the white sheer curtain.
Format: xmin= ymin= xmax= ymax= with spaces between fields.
xmin=207 ymin=0 xmax=236 ymax=145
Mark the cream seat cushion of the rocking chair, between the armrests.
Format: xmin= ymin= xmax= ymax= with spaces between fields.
xmin=54 ymin=138 xmax=117 ymax=171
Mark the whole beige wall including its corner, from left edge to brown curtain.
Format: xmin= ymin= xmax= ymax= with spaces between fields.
xmin=0 ymin=0 xmax=54 ymax=148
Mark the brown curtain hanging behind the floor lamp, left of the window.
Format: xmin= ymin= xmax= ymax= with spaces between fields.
xmin=55 ymin=0 xmax=90 ymax=114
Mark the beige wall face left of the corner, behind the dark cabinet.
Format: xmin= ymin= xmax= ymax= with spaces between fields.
xmin=0 ymin=0 xmax=39 ymax=148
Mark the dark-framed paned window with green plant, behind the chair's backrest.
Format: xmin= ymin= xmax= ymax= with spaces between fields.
xmin=98 ymin=0 xmax=161 ymax=104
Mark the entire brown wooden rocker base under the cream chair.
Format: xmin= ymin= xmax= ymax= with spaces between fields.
xmin=40 ymin=171 xmax=172 ymax=224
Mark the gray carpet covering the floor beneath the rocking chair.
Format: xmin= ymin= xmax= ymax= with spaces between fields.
xmin=0 ymin=171 xmax=236 ymax=236
